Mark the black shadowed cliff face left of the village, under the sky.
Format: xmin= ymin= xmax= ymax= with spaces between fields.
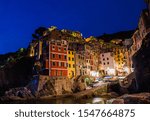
xmin=0 ymin=57 xmax=34 ymax=95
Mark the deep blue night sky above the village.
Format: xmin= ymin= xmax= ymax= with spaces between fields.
xmin=0 ymin=0 xmax=145 ymax=54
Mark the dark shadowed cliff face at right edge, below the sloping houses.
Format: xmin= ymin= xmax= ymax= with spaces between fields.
xmin=133 ymin=34 xmax=150 ymax=92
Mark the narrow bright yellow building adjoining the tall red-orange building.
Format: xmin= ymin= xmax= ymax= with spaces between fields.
xmin=67 ymin=50 xmax=76 ymax=78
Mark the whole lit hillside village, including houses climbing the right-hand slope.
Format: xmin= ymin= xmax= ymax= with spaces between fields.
xmin=30 ymin=2 xmax=150 ymax=79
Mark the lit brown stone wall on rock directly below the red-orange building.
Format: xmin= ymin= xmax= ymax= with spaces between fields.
xmin=38 ymin=75 xmax=72 ymax=96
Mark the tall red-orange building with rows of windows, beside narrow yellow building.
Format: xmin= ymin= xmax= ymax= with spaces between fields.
xmin=49 ymin=40 xmax=68 ymax=77
